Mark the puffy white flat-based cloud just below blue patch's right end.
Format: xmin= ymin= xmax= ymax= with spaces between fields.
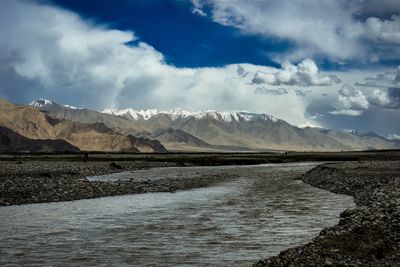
xmin=252 ymin=59 xmax=341 ymax=86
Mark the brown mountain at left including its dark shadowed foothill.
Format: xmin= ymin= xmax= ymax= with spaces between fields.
xmin=0 ymin=99 xmax=166 ymax=152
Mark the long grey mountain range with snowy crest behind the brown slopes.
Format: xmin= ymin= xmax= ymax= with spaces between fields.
xmin=31 ymin=100 xmax=400 ymax=151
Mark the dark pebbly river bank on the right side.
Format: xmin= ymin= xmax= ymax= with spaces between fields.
xmin=254 ymin=161 xmax=400 ymax=266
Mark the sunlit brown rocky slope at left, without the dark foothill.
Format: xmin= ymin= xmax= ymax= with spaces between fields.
xmin=0 ymin=100 xmax=166 ymax=152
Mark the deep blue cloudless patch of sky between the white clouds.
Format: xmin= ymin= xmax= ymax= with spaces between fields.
xmin=54 ymin=0 xmax=289 ymax=67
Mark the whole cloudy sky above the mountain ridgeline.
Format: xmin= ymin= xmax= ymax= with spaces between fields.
xmin=0 ymin=0 xmax=400 ymax=135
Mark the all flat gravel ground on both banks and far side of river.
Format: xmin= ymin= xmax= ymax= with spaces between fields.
xmin=0 ymin=151 xmax=400 ymax=266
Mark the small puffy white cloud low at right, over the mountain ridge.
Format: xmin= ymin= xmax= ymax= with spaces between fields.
xmin=329 ymin=84 xmax=369 ymax=116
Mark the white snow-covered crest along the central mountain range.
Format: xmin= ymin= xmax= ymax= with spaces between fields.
xmin=102 ymin=108 xmax=278 ymax=122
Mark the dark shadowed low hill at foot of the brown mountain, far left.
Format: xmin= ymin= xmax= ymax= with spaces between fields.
xmin=0 ymin=126 xmax=80 ymax=153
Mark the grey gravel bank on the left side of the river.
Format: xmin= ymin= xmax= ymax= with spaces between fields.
xmin=0 ymin=160 xmax=230 ymax=206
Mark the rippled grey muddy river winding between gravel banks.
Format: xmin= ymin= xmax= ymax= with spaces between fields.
xmin=0 ymin=163 xmax=354 ymax=266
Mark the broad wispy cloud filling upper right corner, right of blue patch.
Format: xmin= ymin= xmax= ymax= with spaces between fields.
xmin=195 ymin=0 xmax=400 ymax=61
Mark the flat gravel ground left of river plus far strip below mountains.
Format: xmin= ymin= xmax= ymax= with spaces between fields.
xmin=0 ymin=151 xmax=400 ymax=206
